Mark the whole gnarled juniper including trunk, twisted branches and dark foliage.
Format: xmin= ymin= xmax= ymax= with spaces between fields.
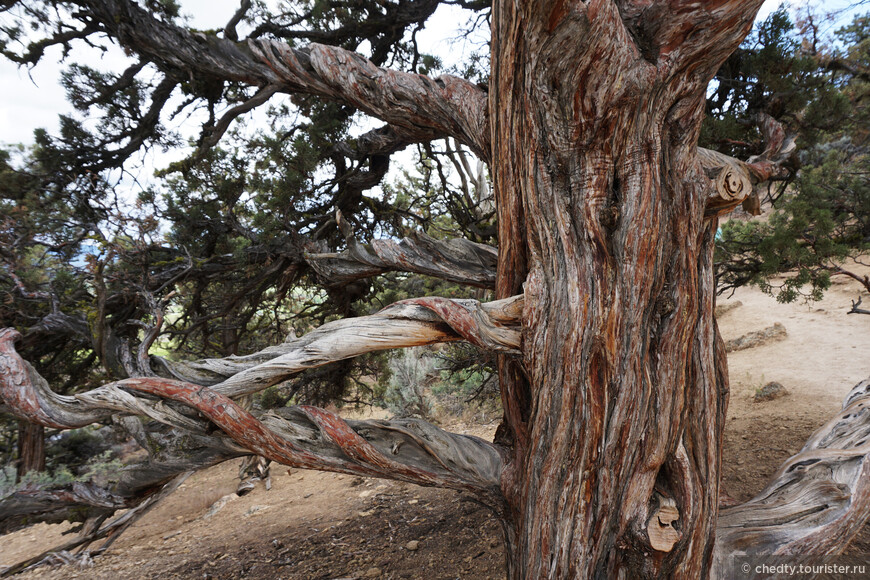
xmin=0 ymin=0 xmax=870 ymax=580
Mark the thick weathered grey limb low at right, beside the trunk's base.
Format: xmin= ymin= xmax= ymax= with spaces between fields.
xmin=714 ymin=379 xmax=870 ymax=578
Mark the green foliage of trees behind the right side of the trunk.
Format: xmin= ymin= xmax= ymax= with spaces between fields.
xmin=707 ymin=9 xmax=870 ymax=313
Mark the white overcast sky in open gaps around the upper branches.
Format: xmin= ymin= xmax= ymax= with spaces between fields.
xmin=0 ymin=0 xmax=860 ymax=155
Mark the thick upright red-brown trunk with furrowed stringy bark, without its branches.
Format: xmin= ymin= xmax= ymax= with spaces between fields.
xmin=489 ymin=2 xmax=758 ymax=579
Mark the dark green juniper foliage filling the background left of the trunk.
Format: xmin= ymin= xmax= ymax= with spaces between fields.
xmin=0 ymin=0 xmax=495 ymax=494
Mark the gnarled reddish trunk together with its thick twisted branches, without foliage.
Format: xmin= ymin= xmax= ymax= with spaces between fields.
xmin=0 ymin=0 xmax=852 ymax=580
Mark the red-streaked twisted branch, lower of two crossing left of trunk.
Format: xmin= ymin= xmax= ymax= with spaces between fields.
xmin=127 ymin=380 xmax=502 ymax=493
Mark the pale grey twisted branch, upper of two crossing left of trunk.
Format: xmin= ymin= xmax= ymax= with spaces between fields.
xmin=0 ymin=296 xmax=522 ymax=428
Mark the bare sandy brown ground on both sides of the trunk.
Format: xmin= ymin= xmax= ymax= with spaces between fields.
xmin=0 ymin=262 xmax=870 ymax=580
